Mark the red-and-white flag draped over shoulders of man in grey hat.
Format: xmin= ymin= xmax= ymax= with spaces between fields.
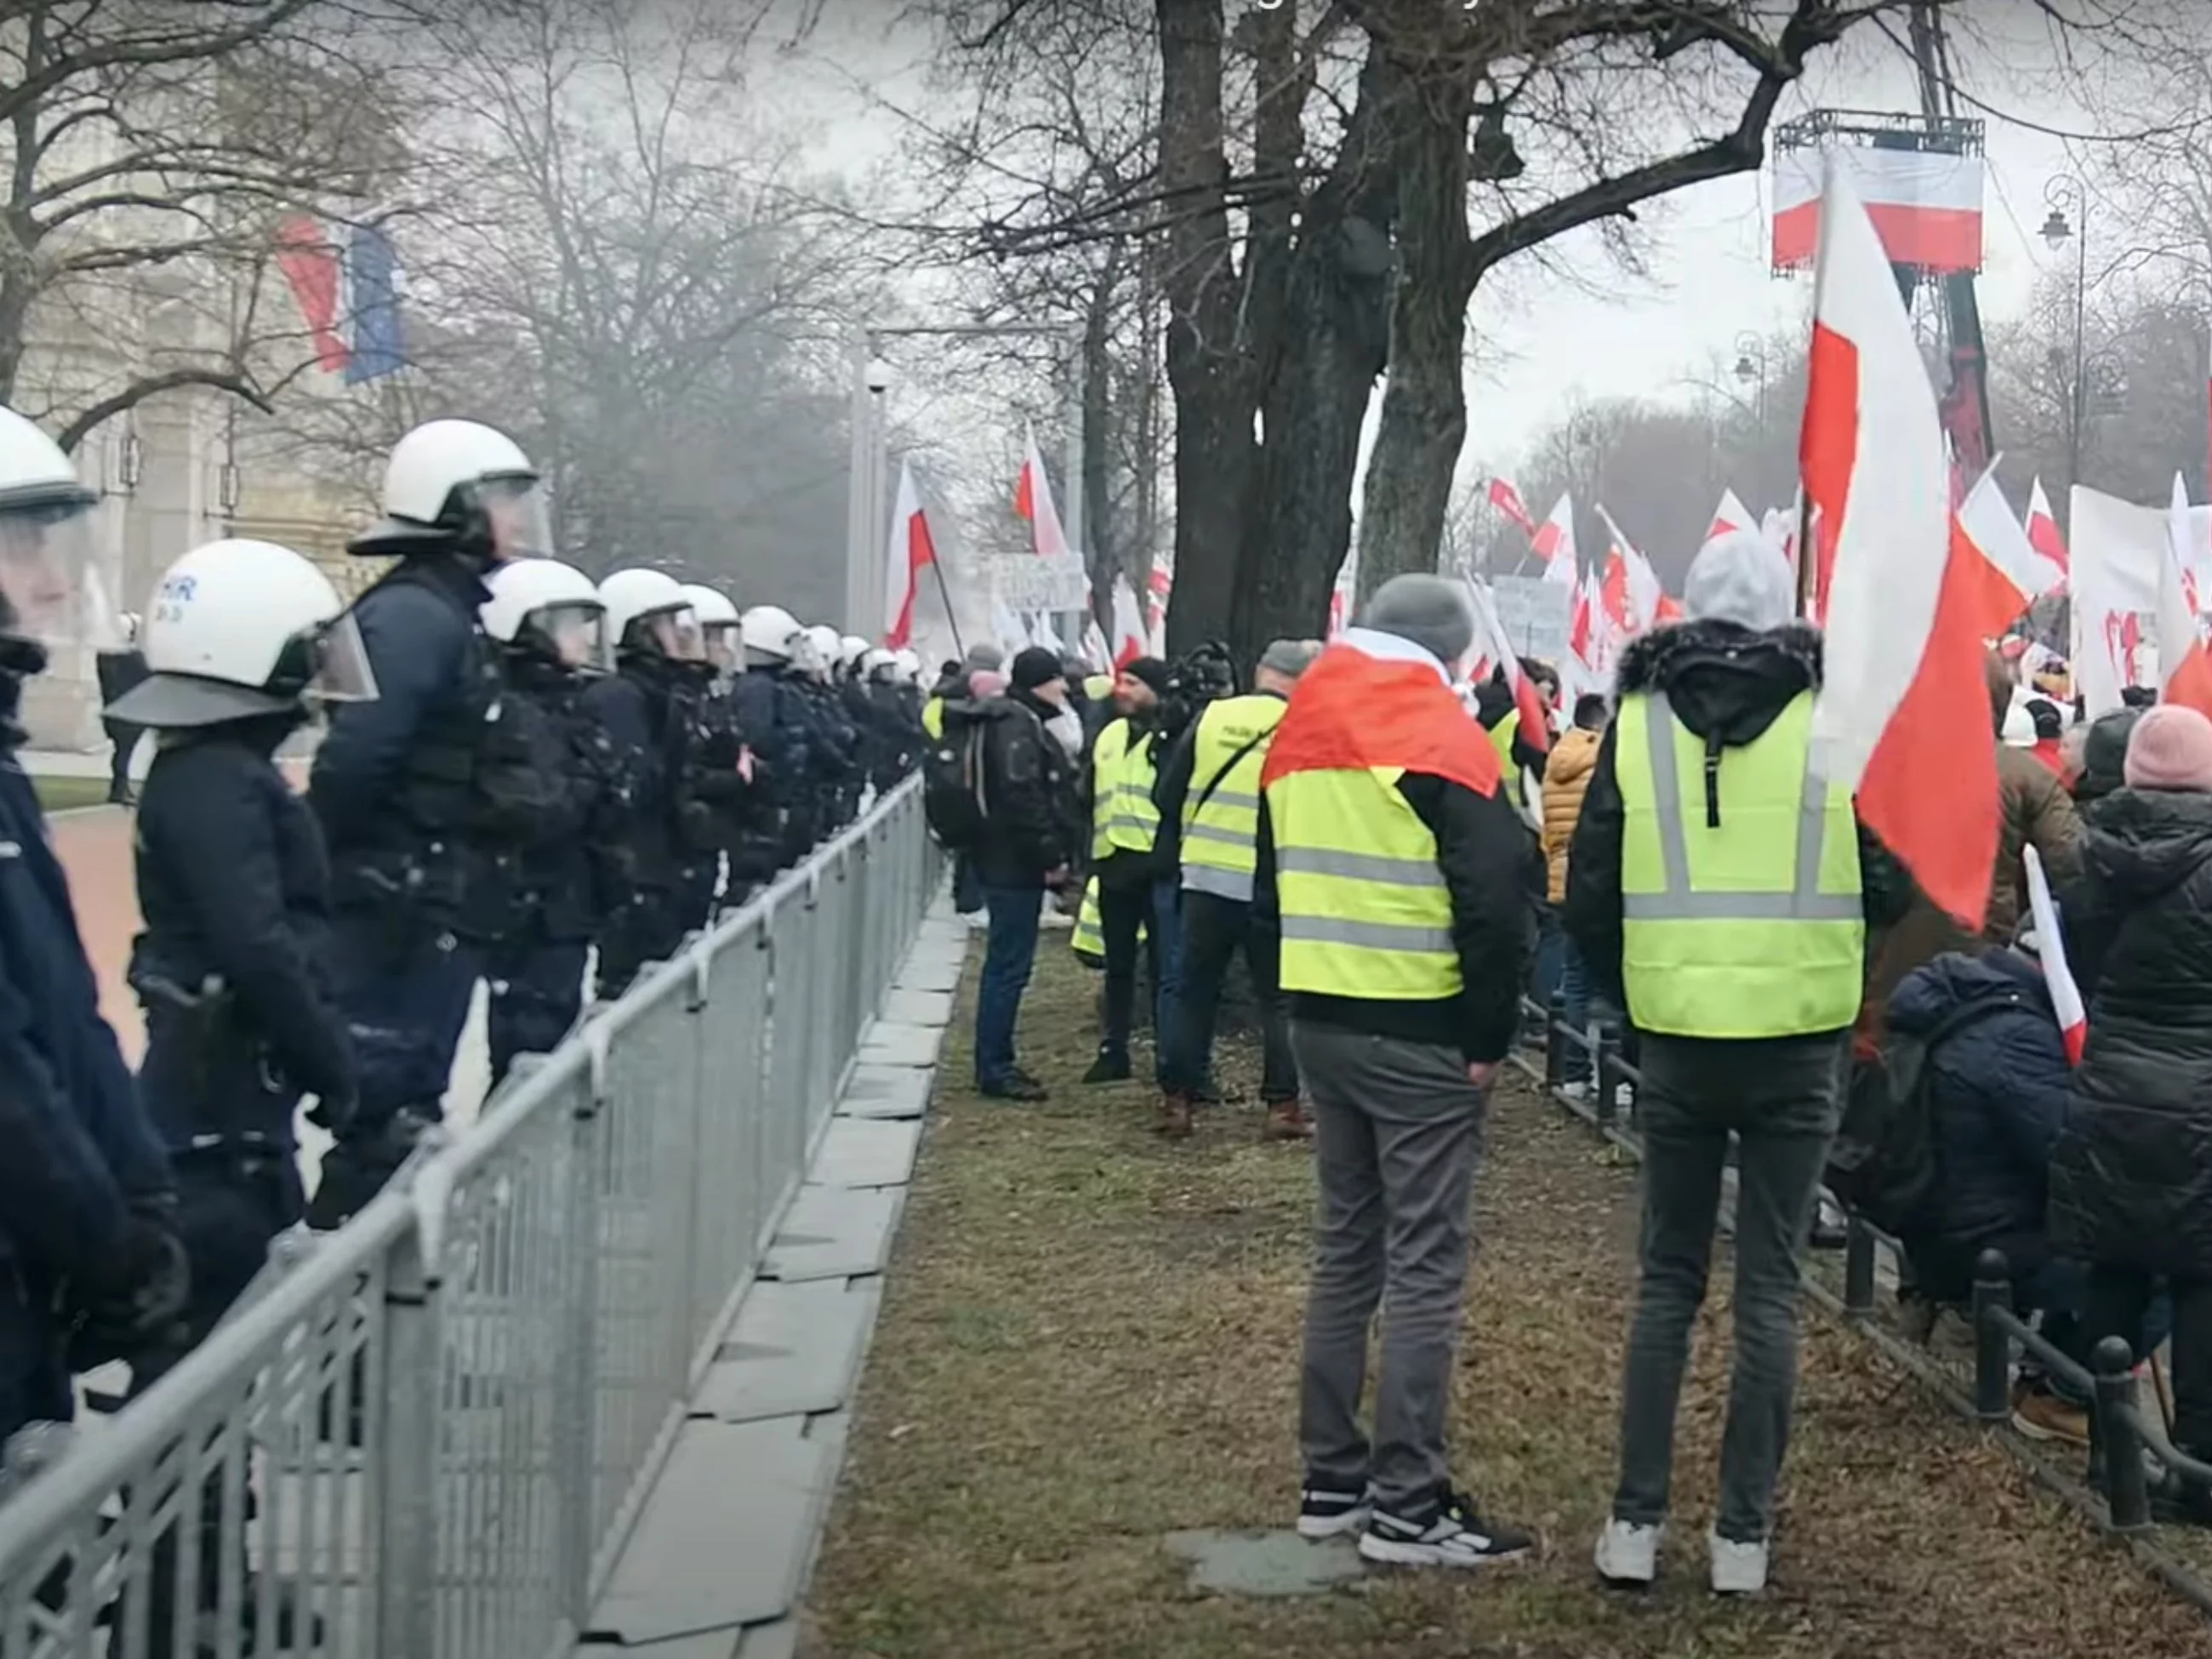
xmin=1258 ymin=628 xmax=1502 ymax=801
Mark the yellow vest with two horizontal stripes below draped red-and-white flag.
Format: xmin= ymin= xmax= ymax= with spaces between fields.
xmin=1268 ymin=766 xmax=1464 ymax=1002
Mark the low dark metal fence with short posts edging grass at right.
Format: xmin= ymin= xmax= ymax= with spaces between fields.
xmin=1522 ymin=998 xmax=2212 ymax=1612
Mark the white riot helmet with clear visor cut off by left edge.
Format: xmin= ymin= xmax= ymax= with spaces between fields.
xmin=0 ymin=409 xmax=105 ymax=675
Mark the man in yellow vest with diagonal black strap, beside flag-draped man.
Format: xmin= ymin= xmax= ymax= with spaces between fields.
xmin=1159 ymin=639 xmax=1320 ymax=1142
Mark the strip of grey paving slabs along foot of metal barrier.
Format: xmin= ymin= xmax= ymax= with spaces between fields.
xmin=578 ymin=900 xmax=969 ymax=1659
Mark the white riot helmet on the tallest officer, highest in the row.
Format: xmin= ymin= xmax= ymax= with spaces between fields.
xmin=345 ymin=420 xmax=553 ymax=567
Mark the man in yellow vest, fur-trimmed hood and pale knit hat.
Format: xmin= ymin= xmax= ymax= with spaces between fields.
xmin=1566 ymin=531 xmax=1911 ymax=1595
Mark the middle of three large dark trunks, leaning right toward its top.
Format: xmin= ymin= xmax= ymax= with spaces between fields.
xmin=1230 ymin=51 xmax=1405 ymax=664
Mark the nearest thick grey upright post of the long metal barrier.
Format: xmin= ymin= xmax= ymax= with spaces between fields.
xmin=373 ymin=1225 xmax=440 ymax=1652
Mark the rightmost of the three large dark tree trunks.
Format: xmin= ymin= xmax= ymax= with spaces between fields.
xmin=1360 ymin=52 xmax=1474 ymax=600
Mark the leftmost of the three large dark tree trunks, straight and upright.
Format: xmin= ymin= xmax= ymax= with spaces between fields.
xmin=1150 ymin=0 xmax=1254 ymax=650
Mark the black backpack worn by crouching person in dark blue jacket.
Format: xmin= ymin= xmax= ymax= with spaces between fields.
xmin=1825 ymin=991 xmax=2027 ymax=1239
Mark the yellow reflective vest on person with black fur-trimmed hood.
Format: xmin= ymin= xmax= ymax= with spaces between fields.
xmin=1612 ymin=693 xmax=1867 ymax=1040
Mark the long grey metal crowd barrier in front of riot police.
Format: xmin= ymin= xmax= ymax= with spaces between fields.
xmin=0 ymin=778 xmax=940 ymax=1659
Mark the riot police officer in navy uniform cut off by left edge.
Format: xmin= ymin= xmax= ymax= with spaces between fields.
xmin=0 ymin=409 xmax=185 ymax=1442
